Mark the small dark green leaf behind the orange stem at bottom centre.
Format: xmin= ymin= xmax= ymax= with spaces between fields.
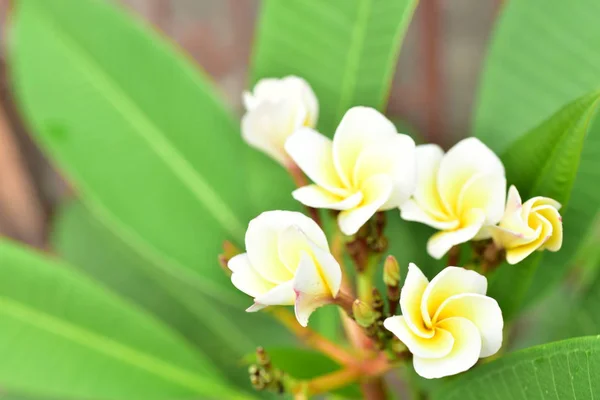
xmin=245 ymin=347 xmax=362 ymax=399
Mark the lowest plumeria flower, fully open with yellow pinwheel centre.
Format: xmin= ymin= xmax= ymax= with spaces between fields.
xmin=383 ymin=264 xmax=504 ymax=379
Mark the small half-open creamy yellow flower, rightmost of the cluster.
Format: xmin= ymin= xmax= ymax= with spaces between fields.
xmin=491 ymin=186 xmax=563 ymax=264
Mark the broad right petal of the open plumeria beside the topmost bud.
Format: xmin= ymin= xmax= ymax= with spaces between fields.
xmin=353 ymin=134 xmax=417 ymax=210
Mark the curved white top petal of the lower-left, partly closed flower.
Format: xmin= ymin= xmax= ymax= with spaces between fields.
xmin=246 ymin=211 xmax=329 ymax=284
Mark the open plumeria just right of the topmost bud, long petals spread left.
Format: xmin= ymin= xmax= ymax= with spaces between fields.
xmin=285 ymin=107 xmax=416 ymax=235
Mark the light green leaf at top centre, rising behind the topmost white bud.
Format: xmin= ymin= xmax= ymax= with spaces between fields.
xmin=251 ymin=0 xmax=417 ymax=135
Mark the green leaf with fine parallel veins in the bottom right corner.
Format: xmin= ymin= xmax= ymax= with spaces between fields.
xmin=432 ymin=336 xmax=600 ymax=400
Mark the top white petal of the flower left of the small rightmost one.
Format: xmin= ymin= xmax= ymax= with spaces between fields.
xmin=438 ymin=137 xmax=504 ymax=214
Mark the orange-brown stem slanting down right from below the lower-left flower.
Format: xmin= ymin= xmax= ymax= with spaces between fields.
xmin=268 ymin=307 xmax=356 ymax=365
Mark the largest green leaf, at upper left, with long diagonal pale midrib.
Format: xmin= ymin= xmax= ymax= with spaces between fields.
xmin=10 ymin=0 xmax=250 ymax=305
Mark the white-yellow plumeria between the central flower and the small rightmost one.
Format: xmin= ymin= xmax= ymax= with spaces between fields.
xmin=401 ymin=138 xmax=506 ymax=259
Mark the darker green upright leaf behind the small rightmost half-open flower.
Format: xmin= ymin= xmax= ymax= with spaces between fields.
xmin=490 ymin=92 xmax=600 ymax=318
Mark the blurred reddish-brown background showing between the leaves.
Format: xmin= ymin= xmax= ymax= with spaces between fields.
xmin=0 ymin=0 xmax=501 ymax=248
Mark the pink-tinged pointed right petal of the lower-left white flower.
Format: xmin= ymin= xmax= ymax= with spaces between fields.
xmin=294 ymin=253 xmax=332 ymax=327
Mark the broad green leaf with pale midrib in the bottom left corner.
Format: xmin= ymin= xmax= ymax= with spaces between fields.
xmin=0 ymin=242 xmax=251 ymax=399
